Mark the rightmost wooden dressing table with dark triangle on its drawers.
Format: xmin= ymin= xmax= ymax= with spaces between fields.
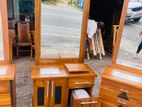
xmin=100 ymin=0 xmax=142 ymax=107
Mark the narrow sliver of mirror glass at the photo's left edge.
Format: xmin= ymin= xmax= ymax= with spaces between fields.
xmin=0 ymin=8 xmax=4 ymax=60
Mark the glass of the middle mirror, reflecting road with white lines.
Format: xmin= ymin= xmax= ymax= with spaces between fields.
xmin=41 ymin=0 xmax=83 ymax=58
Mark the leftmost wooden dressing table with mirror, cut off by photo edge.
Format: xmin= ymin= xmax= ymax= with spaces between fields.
xmin=0 ymin=0 xmax=16 ymax=107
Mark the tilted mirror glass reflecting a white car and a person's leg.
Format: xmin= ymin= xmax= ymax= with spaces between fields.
xmin=117 ymin=1 xmax=142 ymax=69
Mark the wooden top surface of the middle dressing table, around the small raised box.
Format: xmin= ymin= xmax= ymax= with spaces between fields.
xmin=32 ymin=64 xmax=96 ymax=79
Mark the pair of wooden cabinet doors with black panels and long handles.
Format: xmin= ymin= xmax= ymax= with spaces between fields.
xmin=33 ymin=78 xmax=67 ymax=107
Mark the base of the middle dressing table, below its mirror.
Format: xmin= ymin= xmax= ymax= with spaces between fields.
xmin=32 ymin=64 xmax=96 ymax=107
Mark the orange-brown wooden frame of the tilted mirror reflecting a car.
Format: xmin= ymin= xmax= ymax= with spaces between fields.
xmin=112 ymin=0 xmax=140 ymax=71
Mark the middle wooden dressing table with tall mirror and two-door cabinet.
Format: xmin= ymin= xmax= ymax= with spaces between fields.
xmin=31 ymin=0 xmax=96 ymax=107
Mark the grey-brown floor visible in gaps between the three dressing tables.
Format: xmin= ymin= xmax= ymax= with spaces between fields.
xmin=14 ymin=56 xmax=111 ymax=107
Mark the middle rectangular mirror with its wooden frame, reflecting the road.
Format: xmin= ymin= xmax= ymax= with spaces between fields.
xmin=35 ymin=0 xmax=90 ymax=62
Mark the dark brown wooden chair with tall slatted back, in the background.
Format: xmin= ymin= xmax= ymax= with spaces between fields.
xmin=16 ymin=22 xmax=31 ymax=57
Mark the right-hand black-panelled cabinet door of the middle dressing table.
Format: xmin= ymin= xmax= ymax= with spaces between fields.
xmin=50 ymin=78 xmax=68 ymax=107
